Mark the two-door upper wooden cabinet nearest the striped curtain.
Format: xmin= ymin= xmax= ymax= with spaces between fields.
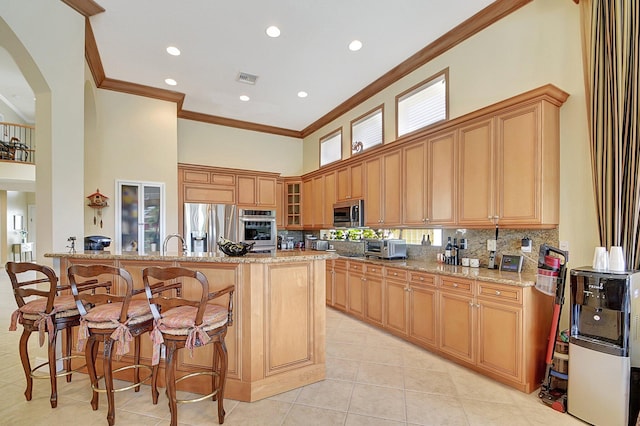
xmin=458 ymin=99 xmax=560 ymax=227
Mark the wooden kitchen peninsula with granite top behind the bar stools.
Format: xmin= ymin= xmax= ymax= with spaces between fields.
xmin=45 ymin=250 xmax=337 ymax=402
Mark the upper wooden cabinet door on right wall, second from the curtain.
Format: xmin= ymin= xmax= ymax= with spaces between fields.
xmin=458 ymin=118 xmax=497 ymax=226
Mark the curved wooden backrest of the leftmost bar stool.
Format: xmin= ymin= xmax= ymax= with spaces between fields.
xmin=5 ymin=262 xmax=58 ymax=313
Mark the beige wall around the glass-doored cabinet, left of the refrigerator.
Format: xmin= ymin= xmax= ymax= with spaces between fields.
xmin=85 ymin=84 xmax=178 ymax=240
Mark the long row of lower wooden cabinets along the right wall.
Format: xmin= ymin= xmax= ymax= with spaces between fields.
xmin=327 ymin=259 xmax=553 ymax=393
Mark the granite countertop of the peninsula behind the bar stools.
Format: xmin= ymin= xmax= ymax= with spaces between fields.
xmin=44 ymin=250 xmax=338 ymax=263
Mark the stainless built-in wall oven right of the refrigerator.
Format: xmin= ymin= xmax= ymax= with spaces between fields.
xmin=238 ymin=209 xmax=277 ymax=252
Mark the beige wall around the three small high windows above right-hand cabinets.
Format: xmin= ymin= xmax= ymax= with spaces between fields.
xmin=303 ymin=0 xmax=597 ymax=266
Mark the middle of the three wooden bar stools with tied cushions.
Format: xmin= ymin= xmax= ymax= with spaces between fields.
xmin=68 ymin=265 xmax=157 ymax=425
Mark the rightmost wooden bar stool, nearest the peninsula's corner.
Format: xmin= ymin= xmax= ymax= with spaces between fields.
xmin=142 ymin=267 xmax=235 ymax=426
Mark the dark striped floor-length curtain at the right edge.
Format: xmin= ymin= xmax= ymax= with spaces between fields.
xmin=580 ymin=0 xmax=640 ymax=269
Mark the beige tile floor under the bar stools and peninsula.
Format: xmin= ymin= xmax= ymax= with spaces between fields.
xmin=0 ymin=268 xmax=583 ymax=426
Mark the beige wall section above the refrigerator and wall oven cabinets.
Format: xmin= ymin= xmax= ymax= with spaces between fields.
xmin=178 ymin=120 xmax=302 ymax=176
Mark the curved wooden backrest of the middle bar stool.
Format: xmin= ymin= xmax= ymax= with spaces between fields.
xmin=67 ymin=265 xmax=133 ymax=323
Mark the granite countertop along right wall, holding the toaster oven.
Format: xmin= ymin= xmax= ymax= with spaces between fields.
xmin=340 ymin=256 xmax=536 ymax=287
